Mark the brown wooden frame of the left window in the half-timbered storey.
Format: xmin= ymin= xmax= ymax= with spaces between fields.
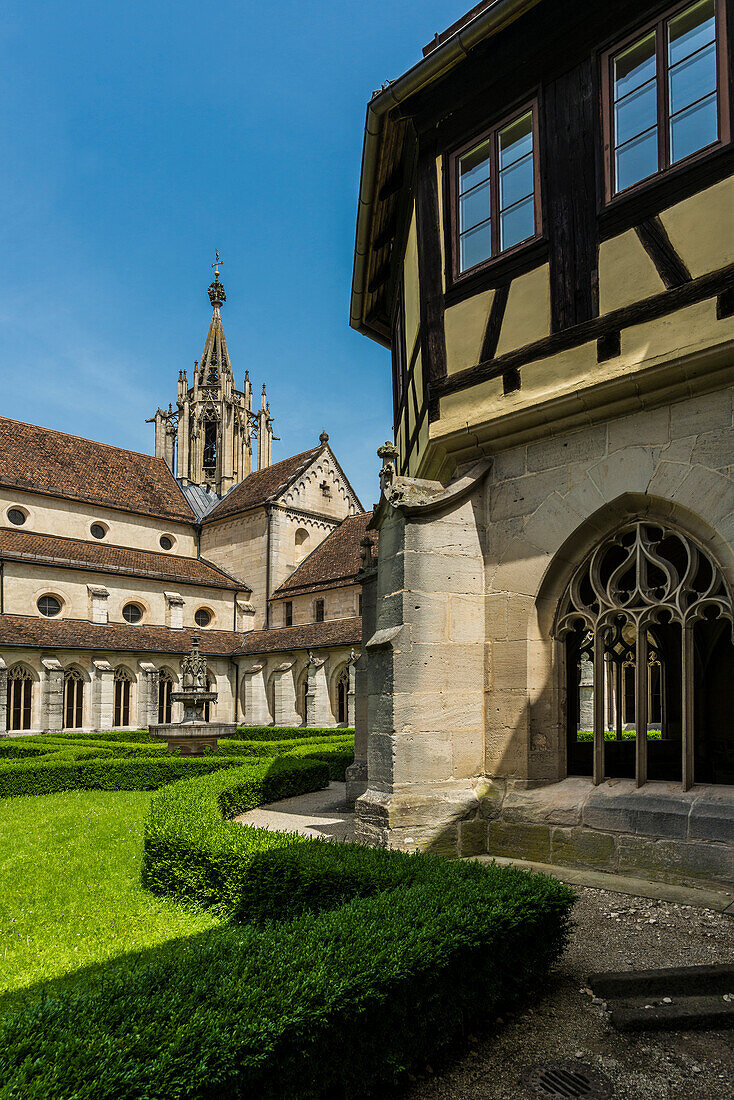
xmin=448 ymin=96 xmax=544 ymax=284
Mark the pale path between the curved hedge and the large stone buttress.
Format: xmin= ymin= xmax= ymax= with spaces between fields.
xmin=234 ymin=782 xmax=354 ymax=840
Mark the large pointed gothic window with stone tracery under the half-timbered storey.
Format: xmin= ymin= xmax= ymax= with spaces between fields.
xmin=556 ymin=521 xmax=734 ymax=790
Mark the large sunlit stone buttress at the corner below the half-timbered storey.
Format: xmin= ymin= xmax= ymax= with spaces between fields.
xmin=355 ymin=448 xmax=489 ymax=855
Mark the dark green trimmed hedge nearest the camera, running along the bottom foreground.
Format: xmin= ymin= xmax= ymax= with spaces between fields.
xmin=0 ymin=864 xmax=570 ymax=1100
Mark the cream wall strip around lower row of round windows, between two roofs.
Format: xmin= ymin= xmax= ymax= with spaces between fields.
xmin=3 ymin=561 xmax=234 ymax=630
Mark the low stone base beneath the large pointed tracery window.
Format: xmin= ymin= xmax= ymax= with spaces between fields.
xmin=481 ymin=778 xmax=734 ymax=888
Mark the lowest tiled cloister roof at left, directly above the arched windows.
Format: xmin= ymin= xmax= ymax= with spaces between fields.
xmin=0 ymin=615 xmax=244 ymax=657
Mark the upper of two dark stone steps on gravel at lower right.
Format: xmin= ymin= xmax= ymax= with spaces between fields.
xmin=589 ymin=964 xmax=734 ymax=1001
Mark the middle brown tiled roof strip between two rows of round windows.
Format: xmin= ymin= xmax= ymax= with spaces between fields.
xmin=0 ymin=527 xmax=250 ymax=592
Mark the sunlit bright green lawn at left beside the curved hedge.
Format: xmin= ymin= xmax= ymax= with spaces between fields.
xmin=0 ymin=791 xmax=222 ymax=1012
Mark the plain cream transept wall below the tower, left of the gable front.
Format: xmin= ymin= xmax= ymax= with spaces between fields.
xmin=201 ymin=507 xmax=267 ymax=630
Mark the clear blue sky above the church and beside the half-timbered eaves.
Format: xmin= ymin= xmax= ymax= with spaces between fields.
xmin=0 ymin=0 xmax=464 ymax=507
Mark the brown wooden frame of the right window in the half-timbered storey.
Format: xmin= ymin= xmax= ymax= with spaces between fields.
xmin=600 ymin=0 xmax=732 ymax=206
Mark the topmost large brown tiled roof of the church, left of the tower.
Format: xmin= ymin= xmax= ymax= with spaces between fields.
xmin=0 ymin=417 xmax=194 ymax=524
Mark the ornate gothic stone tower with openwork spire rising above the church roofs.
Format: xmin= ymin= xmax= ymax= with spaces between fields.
xmin=153 ymin=253 xmax=273 ymax=496
